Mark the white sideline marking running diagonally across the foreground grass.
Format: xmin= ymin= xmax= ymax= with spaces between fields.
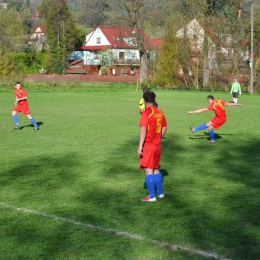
xmin=0 ymin=202 xmax=230 ymax=260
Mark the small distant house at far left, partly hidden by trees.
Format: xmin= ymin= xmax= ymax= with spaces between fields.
xmin=28 ymin=25 xmax=47 ymax=52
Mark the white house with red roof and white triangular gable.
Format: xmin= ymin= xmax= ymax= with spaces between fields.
xmin=70 ymin=26 xmax=159 ymax=73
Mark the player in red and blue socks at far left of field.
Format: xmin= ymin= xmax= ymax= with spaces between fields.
xmin=12 ymin=82 xmax=39 ymax=130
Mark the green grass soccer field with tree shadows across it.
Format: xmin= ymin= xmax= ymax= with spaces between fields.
xmin=0 ymin=85 xmax=260 ymax=260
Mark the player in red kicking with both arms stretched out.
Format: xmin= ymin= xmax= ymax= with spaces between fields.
xmin=188 ymin=95 xmax=241 ymax=143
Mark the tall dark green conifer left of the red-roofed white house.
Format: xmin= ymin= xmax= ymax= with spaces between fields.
xmin=40 ymin=0 xmax=77 ymax=74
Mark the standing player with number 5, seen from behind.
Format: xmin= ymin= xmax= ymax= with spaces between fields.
xmin=137 ymin=91 xmax=167 ymax=202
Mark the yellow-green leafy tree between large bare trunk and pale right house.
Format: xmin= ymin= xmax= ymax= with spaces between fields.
xmin=156 ymin=13 xmax=201 ymax=89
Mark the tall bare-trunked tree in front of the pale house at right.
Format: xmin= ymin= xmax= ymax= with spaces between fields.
xmin=178 ymin=0 xmax=249 ymax=87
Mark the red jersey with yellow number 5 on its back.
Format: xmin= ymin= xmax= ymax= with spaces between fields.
xmin=139 ymin=106 xmax=167 ymax=145
